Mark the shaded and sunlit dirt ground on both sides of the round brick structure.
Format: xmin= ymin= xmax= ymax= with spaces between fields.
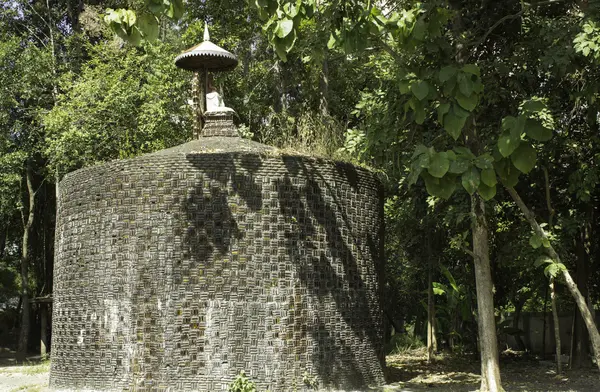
xmin=0 ymin=349 xmax=600 ymax=392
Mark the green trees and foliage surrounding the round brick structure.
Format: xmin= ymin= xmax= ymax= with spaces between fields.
xmin=0 ymin=0 xmax=600 ymax=391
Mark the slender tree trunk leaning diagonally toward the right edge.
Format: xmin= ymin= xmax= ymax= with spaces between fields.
xmin=506 ymin=187 xmax=600 ymax=369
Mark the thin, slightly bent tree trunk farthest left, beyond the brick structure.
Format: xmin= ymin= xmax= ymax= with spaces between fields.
xmin=17 ymin=159 xmax=35 ymax=361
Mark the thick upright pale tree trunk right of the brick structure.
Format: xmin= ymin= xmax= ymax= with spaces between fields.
xmin=471 ymin=194 xmax=503 ymax=392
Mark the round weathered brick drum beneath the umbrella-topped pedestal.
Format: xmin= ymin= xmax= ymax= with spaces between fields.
xmin=50 ymin=136 xmax=384 ymax=392
